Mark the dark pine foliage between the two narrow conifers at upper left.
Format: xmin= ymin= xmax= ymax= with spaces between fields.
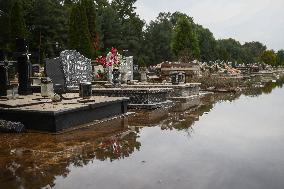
xmin=24 ymin=0 xmax=69 ymax=62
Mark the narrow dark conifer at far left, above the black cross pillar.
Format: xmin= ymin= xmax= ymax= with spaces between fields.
xmin=10 ymin=1 xmax=27 ymax=46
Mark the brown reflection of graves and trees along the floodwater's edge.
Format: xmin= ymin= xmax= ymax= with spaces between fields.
xmin=0 ymin=77 xmax=284 ymax=188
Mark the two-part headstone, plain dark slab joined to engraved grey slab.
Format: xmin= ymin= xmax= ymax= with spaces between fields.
xmin=46 ymin=50 xmax=92 ymax=90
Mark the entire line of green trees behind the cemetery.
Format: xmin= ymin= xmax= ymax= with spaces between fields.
xmin=0 ymin=0 xmax=284 ymax=65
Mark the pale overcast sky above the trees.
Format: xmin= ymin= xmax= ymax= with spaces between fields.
xmin=136 ymin=0 xmax=284 ymax=50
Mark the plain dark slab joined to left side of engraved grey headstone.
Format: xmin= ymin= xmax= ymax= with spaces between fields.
xmin=45 ymin=58 xmax=66 ymax=91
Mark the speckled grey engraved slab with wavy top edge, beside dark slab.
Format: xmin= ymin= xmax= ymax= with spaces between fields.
xmin=60 ymin=50 xmax=92 ymax=89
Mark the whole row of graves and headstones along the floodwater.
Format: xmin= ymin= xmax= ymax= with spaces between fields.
xmin=0 ymin=39 xmax=283 ymax=132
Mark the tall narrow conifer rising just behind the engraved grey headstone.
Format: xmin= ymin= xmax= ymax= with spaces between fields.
xmin=69 ymin=2 xmax=94 ymax=58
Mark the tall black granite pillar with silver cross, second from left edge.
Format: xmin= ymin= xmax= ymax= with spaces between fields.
xmin=16 ymin=38 xmax=32 ymax=95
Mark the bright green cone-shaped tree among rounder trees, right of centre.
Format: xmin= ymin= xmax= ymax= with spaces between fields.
xmin=172 ymin=16 xmax=200 ymax=59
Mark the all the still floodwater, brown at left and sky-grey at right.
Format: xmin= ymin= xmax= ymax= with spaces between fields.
xmin=0 ymin=80 xmax=284 ymax=189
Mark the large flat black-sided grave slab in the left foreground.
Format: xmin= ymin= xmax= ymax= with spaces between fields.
xmin=0 ymin=93 xmax=128 ymax=132
